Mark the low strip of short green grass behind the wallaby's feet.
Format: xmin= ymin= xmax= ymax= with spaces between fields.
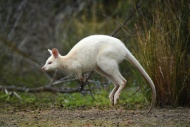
xmin=0 ymin=88 xmax=147 ymax=109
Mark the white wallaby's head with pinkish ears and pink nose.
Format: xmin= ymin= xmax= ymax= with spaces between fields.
xmin=42 ymin=48 xmax=61 ymax=71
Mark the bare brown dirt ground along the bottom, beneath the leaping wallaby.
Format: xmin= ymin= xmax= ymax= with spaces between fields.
xmin=0 ymin=106 xmax=190 ymax=127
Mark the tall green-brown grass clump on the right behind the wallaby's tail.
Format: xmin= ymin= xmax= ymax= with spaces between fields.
xmin=133 ymin=0 xmax=190 ymax=106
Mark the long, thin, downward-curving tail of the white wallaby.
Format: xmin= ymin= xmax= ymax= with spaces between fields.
xmin=126 ymin=52 xmax=156 ymax=113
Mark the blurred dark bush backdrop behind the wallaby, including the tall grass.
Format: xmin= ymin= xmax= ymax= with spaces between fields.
xmin=0 ymin=0 xmax=190 ymax=106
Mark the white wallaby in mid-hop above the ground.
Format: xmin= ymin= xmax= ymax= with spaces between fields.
xmin=42 ymin=35 xmax=156 ymax=113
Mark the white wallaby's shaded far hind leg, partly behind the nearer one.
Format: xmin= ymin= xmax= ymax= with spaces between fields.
xmin=95 ymin=67 xmax=119 ymax=106
